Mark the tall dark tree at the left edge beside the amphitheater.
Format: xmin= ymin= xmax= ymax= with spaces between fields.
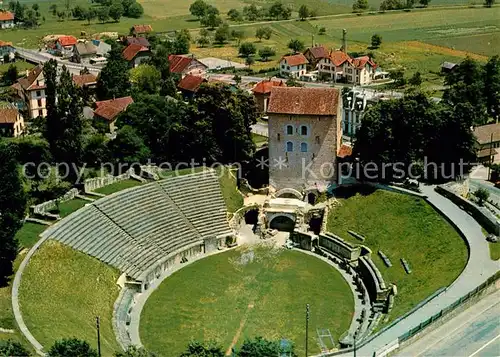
xmin=0 ymin=140 xmax=26 ymax=286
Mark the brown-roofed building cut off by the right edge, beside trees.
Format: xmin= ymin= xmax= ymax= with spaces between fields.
xmin=474 ymin=123 xmax=500 ymax=164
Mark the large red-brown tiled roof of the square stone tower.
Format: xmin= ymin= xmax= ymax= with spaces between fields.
xmin=267 ymin=87 xmax=339 ymax=115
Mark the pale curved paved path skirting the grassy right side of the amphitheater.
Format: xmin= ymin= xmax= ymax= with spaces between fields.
xmin=336 ymin=186 xmax=500 ymax=357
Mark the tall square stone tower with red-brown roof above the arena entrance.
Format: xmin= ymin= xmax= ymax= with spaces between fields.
xmin=267 ymin=87 xmax=342 ymax=191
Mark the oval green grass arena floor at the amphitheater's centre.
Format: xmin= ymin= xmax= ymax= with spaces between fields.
xmin=140 ymin=246 xmax=354 ymax=357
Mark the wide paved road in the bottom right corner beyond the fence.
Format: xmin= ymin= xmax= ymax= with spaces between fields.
xmin=396 ymin=290 xmax=500 ymax=357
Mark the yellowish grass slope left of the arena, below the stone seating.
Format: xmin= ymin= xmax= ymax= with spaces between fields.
xmin=19 ymin=240 xmax=119 ymax=357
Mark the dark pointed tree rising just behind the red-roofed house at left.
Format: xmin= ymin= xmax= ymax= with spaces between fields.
xmin=96 ymin=44 xmax=130 ymax=100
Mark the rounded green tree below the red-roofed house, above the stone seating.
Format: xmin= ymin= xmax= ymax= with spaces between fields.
xmin=109 ymin=125 xmax=151 ymax=164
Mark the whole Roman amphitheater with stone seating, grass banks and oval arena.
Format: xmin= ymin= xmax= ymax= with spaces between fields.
xmin=12 ymin=169 xmax=498 ymax=357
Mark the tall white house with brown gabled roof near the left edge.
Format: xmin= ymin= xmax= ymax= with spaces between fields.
xmin=12 ymin=65 xmax=47 ymax=119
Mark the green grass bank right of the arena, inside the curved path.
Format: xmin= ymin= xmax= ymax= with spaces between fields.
xmin=328 ymin=190 xmax=468 ymax=320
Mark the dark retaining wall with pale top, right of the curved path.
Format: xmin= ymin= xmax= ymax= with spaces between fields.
xmin=435 ymin=185 xmax=500 ymax=236
